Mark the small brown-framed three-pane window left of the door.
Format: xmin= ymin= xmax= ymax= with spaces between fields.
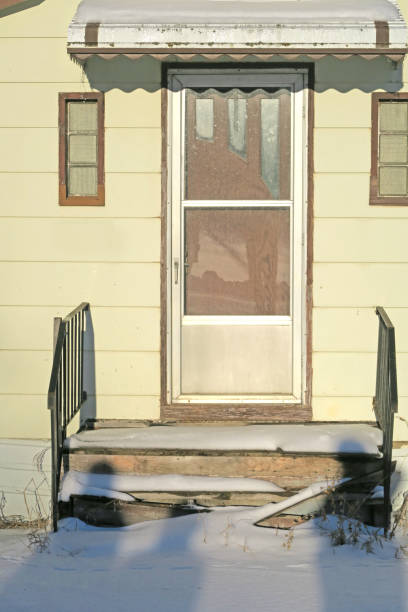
xmin=59 ymin=93 xmax=105 ymax=206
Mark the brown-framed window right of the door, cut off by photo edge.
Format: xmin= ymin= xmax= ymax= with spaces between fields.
xmin=370 ymin=93 xmax=408 ymax=205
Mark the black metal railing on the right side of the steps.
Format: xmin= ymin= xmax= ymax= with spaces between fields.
xmin=373 ymin=306 xmax=398 ymax=532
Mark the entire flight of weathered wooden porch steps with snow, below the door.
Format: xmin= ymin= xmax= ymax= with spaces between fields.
xmin=62 ymin=422 xmax=383 ymax=527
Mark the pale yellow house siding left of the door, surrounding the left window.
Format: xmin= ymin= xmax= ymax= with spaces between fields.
xmin=0 ymin=0 xmax=161 ymax=438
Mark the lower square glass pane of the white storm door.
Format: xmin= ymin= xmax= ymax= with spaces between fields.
xmin=184 ymin=208 xmax=290 ymax=315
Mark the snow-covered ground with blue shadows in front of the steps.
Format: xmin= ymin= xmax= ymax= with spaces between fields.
xmin=0 ymin=508 xmax=408 ymax=612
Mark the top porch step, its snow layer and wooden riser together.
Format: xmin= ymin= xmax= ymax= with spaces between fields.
xmin=64 ymin=424 xmax=382 ymax=490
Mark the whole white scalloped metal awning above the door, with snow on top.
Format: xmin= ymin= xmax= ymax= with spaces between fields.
xmin=68 ymin=0 xmax=407 ymax=61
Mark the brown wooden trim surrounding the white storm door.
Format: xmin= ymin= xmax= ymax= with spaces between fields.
xmin=160 ymin=62 xmax=314 ymax=422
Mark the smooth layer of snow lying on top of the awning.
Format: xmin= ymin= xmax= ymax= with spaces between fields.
xmin=73 ymin=0 xmax=401 ymax=25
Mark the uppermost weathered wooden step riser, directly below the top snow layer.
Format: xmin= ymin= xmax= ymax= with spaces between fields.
xmin=64 ymin=451 xmax=382 ymax=490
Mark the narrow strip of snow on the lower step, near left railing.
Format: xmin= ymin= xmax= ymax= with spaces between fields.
xmin=60 ymin=470 xmax=283 ymax=501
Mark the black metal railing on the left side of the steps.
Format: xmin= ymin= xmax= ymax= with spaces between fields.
xmin=48 ymin=302 xmax=89 ymax=531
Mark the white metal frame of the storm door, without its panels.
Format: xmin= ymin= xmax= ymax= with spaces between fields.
xmin=166 ymin=67 xmax=309 ymax=405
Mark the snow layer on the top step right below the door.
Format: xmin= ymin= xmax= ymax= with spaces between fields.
xmin=65 ymin=424 xmax=382 ymax=455
